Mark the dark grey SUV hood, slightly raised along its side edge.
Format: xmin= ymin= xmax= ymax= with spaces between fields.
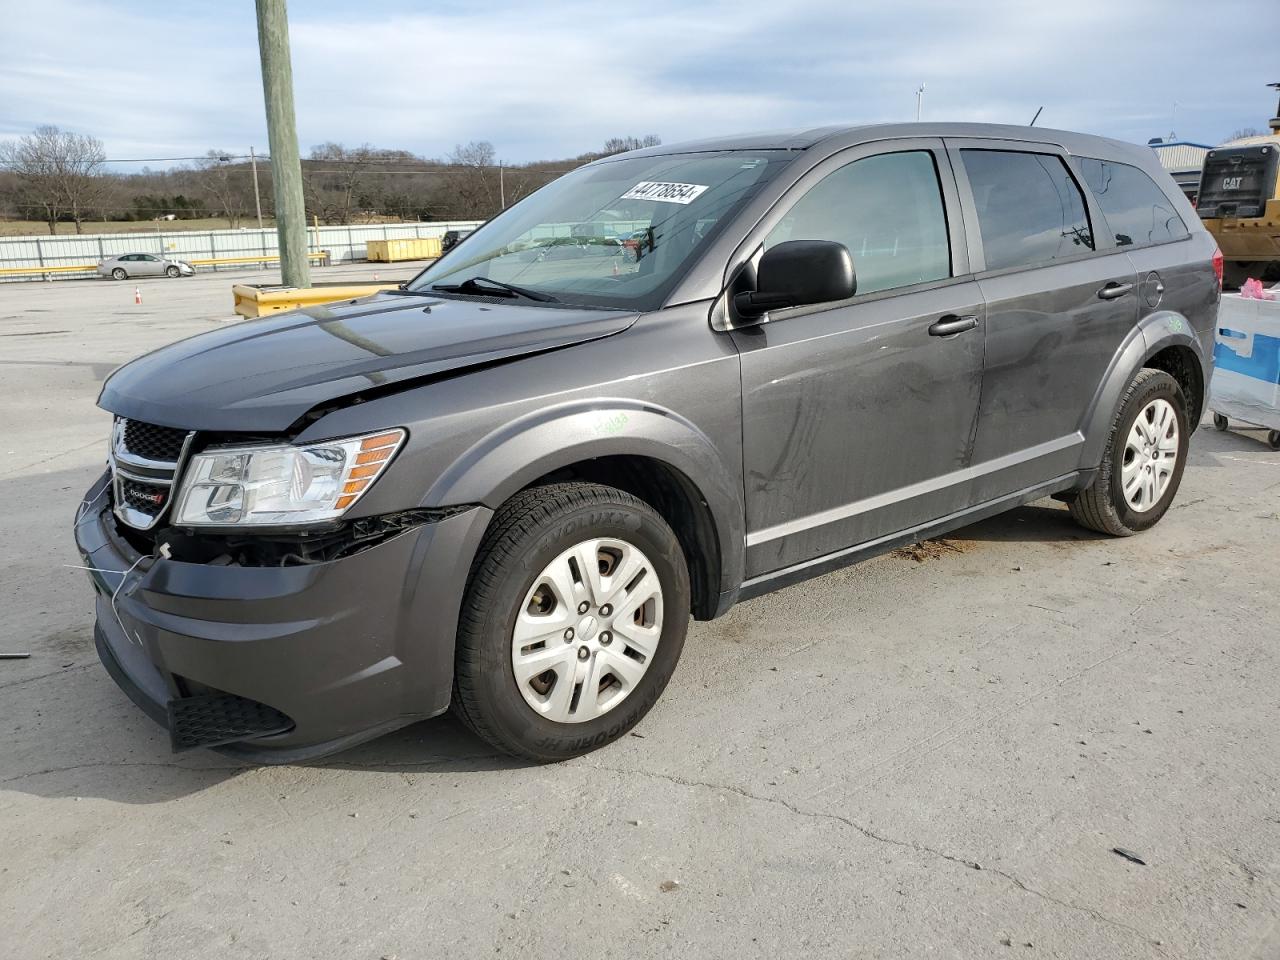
xmin=97 ymin=293 xmax=637 ymax=433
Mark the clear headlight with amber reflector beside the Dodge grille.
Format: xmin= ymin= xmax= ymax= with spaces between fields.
xmin=173 ymin=430 xmax=404 ymax=526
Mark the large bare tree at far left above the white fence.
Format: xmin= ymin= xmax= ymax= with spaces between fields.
xmin=0 ymin=127 xmax=106 ymax=234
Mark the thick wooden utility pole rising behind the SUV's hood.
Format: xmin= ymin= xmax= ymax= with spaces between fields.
xmin=256 ymin=0 xmax=311 ymax=287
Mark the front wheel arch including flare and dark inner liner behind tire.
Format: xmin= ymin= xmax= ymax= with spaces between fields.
xmin=424 ymin=401 xmax=745 ymax=620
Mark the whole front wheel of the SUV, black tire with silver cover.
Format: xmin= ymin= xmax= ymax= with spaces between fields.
xmin=453 ymin=483 xmax=690 ymax=763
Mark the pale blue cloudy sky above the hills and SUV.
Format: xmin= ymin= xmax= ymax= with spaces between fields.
xmin=0 ymin=0 xmax=1280 ymax=165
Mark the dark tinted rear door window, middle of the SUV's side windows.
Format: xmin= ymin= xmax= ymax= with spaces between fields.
xmin=960 ymin=150 xmax=1093 ymax=270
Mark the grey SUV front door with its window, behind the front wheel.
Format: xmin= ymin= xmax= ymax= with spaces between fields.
xmin=732 ymin=140 xmax=983 ymax=576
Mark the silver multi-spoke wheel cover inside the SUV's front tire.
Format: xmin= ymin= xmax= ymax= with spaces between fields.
xmin=511 ymin=538 xmax=662 ymax=723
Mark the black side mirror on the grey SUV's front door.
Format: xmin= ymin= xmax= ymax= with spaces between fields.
xmin=733 ymin=241 xmax=858 ymax=317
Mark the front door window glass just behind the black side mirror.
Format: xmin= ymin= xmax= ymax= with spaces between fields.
xmin=764 ymin=151 xmax=951 ymax=293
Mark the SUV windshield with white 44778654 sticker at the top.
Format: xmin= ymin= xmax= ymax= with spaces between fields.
xmin=407 ymin=151 xmax=791 ymax=310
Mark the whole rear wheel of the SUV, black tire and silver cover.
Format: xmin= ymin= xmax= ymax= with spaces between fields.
xmin=1070 ymin=367 xmax=1190 ymax=536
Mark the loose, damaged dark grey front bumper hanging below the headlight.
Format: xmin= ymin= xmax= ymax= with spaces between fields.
xmin=76 ymin=475 xmax=490 ymax=763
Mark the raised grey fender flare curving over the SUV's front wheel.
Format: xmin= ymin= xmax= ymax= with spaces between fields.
xmin=422 ymin=398 xmax=745 ymax=591
